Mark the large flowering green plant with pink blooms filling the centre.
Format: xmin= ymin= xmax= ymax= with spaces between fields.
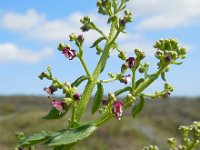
xmin=16 ymin=0 xmax=186 ymax=150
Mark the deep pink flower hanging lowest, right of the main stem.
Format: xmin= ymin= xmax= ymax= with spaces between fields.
xmin=112 ymin=101 xmax=123 ymax=120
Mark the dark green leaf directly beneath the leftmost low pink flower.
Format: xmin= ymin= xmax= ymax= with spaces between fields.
xmin=42 ymin=106 xmax=69 ymax=120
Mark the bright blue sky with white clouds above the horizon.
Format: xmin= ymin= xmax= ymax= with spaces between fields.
xmin=0 ymin=0 xmax=200 ymax=96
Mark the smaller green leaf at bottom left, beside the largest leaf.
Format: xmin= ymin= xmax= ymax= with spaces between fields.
xmin=19 ymin=133 xmax=50 ymax=147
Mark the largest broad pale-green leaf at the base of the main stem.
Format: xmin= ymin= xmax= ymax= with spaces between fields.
xmin=46 ymin=124 xmax=97 ymax=147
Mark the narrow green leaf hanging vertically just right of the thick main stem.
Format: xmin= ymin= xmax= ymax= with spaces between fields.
xmin=92 ymin=83 xmax=103 ymax=114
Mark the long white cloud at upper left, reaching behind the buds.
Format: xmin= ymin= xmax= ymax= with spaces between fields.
xmin=0 ymin=9 xmax=107 ymax=43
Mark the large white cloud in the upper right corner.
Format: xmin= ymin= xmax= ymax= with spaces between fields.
xmin=130 ymin=0 xmax=200 ymax=30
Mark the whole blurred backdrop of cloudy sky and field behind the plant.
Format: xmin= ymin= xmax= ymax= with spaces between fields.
xmin=0 ymin=0 xmax=200 ymax=150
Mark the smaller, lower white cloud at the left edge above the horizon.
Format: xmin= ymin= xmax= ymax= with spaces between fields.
xmin=0 ymin=43 xmax=53 ymax=63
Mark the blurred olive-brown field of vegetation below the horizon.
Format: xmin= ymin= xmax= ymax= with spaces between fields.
xmin=0 ymin=96 xmax=200 ymax=150
